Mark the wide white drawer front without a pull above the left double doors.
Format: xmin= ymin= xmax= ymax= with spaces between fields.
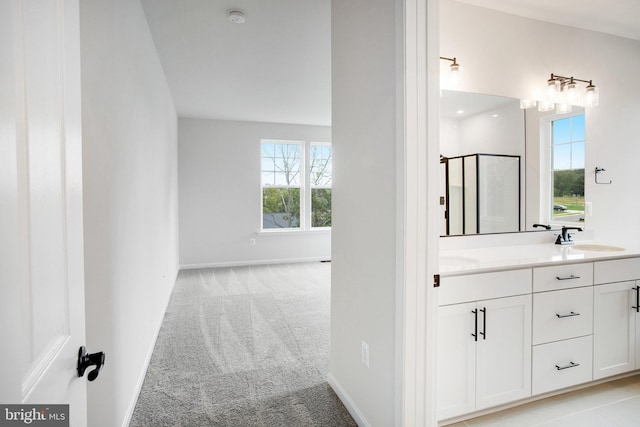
xmin=438 ymin=269 xmax=531 ymax=305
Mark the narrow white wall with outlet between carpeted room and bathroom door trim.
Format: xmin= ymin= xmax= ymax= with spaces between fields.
xmin=329 ymin=0 xmax=401 ymax=426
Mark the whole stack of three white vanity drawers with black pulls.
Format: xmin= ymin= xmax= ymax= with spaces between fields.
xmin=532 ymin=263 xmax=593 ymax=395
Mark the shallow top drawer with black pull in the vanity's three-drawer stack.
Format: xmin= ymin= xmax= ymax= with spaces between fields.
xmin=533 ymin=263 xmax=593 ymax=292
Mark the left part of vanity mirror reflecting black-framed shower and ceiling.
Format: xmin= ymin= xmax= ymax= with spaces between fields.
xmin=440 ymin=90 xmax=527 ymax=235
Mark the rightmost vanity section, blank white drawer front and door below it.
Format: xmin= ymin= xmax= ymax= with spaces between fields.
xmin=593 ymin=258 xmax=640 ymax=379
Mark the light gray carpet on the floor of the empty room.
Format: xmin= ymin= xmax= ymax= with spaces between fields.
xmin=130 ymin=262 xmax=356 ymax=427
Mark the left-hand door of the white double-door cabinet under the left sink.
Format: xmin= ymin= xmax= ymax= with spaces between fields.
xmin=438 ymin=303 xmax=476 ymax=420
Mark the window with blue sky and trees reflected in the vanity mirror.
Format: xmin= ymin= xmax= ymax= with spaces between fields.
xmin=551 ymin=114 xmax=585 ymax=222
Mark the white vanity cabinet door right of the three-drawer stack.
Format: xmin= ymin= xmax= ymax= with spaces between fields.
xmin=593 ymin=282 xmax=635 ymax=380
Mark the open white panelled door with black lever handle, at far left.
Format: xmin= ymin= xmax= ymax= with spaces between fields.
xmin=0 ymin=0 xmax=87 ymax=426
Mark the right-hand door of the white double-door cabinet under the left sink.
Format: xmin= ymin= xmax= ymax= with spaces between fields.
xmin=476 ymin=295 xmax=531 ymax=410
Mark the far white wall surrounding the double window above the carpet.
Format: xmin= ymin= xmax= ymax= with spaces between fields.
xmin=178 ymin=118 xmax=331 ymax=268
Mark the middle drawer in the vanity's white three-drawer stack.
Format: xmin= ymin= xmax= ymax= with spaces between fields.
xmin=533 ymin=286 xmax=593 ymax=345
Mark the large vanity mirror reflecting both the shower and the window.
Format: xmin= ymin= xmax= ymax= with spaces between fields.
xmin=440 ymin=90 xmax=586 ymax=236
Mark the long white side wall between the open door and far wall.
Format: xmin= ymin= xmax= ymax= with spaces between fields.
xmin=80 ymin=0 xmax=178 ymax=427
